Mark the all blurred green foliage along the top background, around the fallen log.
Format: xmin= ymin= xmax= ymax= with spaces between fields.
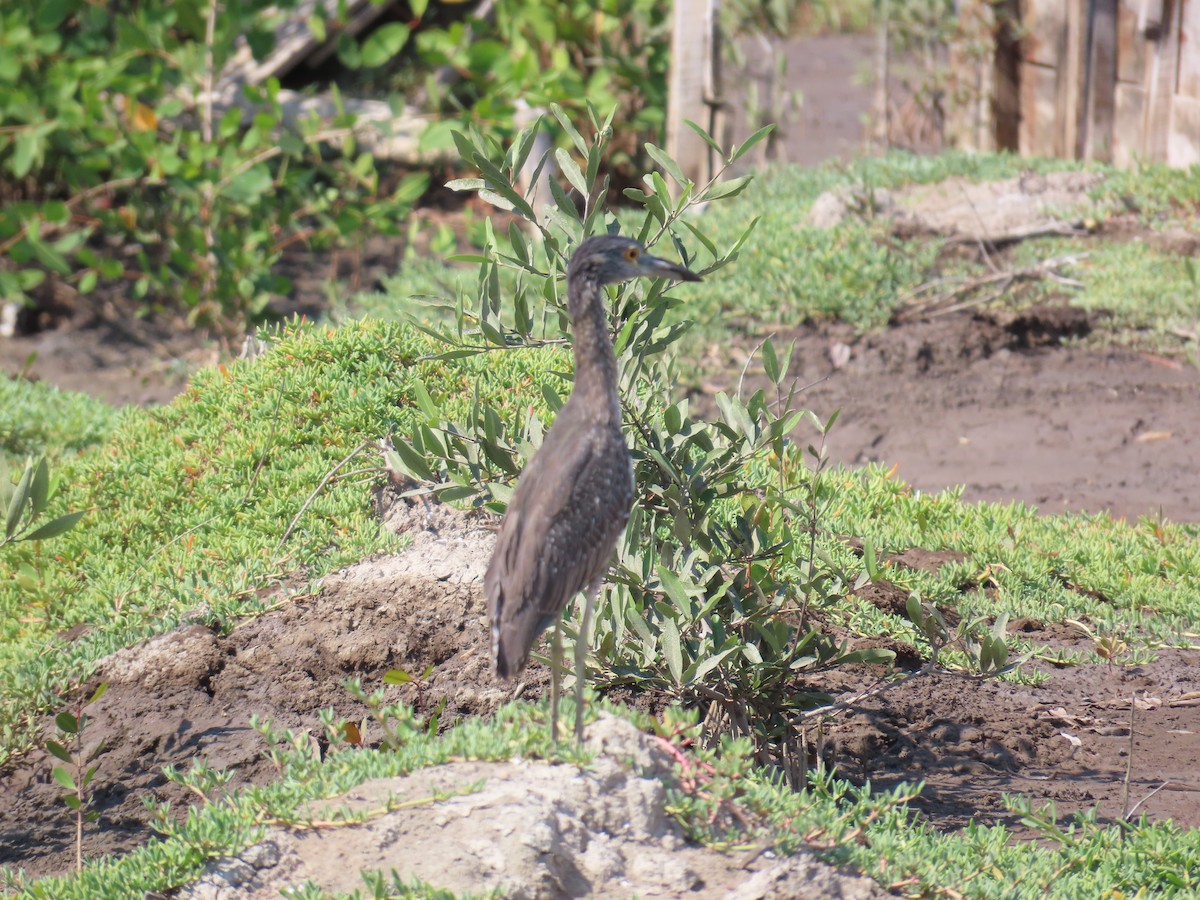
xmin=0 ymin=0 xmax=870 ymax=336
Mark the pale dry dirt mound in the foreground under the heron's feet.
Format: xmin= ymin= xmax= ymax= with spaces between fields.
xmin=180 ymin=716 xmax=889 ymax=900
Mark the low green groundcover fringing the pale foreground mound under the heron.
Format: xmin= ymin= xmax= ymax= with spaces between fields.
xmin=9 ymin=702 xmax=1200 ymax=900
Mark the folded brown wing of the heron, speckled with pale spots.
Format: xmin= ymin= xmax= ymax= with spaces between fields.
xmin=484 ymin=408 xmax=634 ymax=678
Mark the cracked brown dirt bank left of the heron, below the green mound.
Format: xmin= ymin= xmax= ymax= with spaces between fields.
xmin=0 ymin=494 xmax=535 ymax=875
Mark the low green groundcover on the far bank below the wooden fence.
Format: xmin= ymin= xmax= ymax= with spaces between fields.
xmin=372 ymin=152 xmax=1200 ymax=358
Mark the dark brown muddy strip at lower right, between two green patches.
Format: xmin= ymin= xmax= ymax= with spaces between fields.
xmin=828 ymin=632 xmax=1200 ymax=832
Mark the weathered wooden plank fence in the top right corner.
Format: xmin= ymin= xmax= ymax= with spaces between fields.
xmin=952 ymin=0 xmax=1200 ymax=167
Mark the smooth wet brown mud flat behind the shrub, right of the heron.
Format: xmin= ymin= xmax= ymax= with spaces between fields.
xmin=697 ymin=306 xmax=1200 ymax=522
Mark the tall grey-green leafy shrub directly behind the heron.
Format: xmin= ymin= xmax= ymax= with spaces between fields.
xmin=386 ymin=108 xmax=893 ymax=751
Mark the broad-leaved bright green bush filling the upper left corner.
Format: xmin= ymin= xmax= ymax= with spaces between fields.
xmin=0 ymin=0 xmax=425 ymax=329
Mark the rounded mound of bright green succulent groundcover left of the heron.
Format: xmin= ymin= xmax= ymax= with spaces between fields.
xmin=0 ymin=323 xmax=563 ymax=758
